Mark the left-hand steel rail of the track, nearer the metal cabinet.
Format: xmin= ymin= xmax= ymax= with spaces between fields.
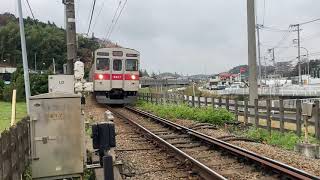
xmin=108 ymin=107 xmax=226 ymax=180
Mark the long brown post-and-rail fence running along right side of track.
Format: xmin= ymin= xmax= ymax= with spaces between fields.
xmin=138 ymin=93 xmax=320 ymax=139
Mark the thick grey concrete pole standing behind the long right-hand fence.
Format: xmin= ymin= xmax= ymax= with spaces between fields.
xmin=247 ymin=0 xmax=258 ymax=105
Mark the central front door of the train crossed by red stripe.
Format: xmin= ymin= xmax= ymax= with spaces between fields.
xmin=111 ymin=59 xmax=124 ymax=89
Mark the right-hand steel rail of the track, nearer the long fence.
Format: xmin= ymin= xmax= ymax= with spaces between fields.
xmin=125 ymin=106 xmax=320 ymax=180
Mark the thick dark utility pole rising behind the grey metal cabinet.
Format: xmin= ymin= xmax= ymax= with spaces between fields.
xmin=62 ymin=0 xmax=77 ymax=75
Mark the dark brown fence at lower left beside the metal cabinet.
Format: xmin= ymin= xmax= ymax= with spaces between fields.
xmin=0 ymin=118 xmax=30 ymax=180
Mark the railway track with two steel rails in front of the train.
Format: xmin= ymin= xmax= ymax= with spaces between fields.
xmin=108 ymin=107 xmax=319 ymax=180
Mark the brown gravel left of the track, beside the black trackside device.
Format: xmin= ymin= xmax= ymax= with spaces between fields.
xmin=84 ymin=97 xmax=200 ymax=180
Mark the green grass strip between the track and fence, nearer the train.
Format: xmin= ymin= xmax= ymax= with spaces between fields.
xmin=137 ymin=101 xmax=234 ymax=125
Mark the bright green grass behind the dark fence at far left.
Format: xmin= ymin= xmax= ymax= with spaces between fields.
xmin=0 ymin=101 xmax=27 ymax=132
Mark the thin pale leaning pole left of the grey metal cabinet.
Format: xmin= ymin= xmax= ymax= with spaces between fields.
xmin=17 ymin=0 xmax=30 ymax=114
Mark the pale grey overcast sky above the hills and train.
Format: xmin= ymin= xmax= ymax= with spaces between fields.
xmin=0 ymin=0 xmax=320 ymax=74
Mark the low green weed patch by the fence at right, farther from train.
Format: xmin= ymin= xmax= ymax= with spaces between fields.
xmin=238 ymin=127 xmax=319 ymax=150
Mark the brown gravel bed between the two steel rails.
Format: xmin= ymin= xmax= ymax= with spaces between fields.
xmin=117 ymin=109 xmax=277 ymax=180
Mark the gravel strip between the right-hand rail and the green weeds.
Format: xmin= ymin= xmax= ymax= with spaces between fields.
xmin=136 ymin=107 xmax=320 ymax=176
